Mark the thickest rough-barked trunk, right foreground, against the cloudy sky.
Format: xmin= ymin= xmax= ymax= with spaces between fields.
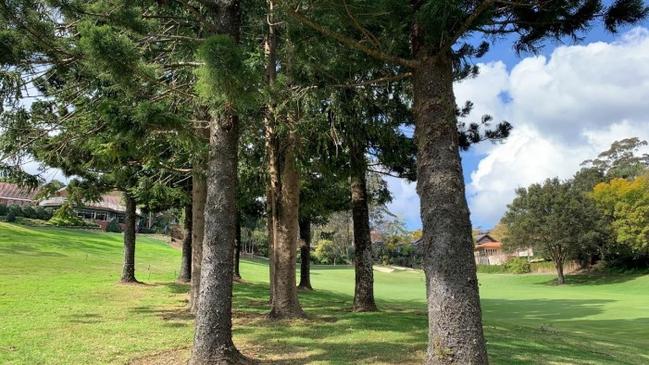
xmin=413 ymin=53 xmax=488 ymax=364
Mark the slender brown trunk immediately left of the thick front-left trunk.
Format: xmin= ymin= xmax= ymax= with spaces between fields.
xmin=189 ymin=168 xmax=207 ymax=314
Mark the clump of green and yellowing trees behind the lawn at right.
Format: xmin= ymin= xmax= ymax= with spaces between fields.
xmin=500 ymin=138 xmax=649 ymax=284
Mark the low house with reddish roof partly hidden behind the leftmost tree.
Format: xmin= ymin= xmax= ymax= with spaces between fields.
xmin=39 ymin=188 xmax=137 ymax=229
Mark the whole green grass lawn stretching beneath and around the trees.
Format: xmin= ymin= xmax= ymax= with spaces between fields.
xmin=0 ymin=223 xmax=649 ymax=365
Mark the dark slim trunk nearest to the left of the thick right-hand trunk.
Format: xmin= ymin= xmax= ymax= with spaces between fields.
xmin=351 ymin=147 xmax=377 ymax=312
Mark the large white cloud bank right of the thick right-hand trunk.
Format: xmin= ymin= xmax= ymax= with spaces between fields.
xmin=464 ymin=28 xmax=649 ymax=225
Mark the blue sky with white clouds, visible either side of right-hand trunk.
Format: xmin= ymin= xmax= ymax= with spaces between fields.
xmin=387 ymin=16 xmax=649 ymax=230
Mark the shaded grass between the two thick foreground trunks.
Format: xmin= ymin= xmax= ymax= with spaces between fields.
xmin=234 ymin=284 xmax=427 ymax=364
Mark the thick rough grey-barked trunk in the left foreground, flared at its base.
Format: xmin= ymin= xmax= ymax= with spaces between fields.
xmin=189 ymin=0 xmax=250 ymax=365
